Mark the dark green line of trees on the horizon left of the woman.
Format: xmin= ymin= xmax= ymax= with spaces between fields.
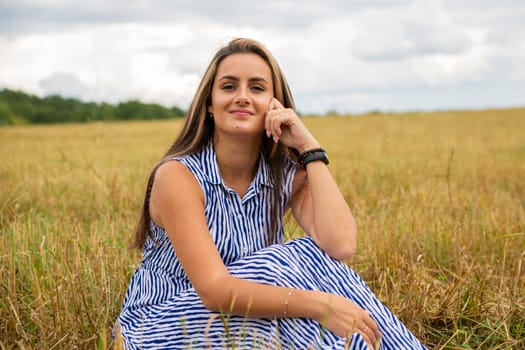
xmin=0 ymin=89 xmax=185 ymax=126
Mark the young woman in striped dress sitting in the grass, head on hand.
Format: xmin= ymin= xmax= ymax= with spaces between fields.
xmin=118 ymin=39 xmax=424 ymax=349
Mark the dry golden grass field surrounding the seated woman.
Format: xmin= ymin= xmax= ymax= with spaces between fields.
xmin=0 ymin=109 xmax=525 ymax=349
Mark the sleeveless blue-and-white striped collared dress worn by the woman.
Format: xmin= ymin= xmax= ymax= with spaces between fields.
xmin=115 ymin=142 xmax=425 ymax=349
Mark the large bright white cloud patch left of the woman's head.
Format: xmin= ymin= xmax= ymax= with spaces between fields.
xmin=0 ymin=22 xmax=278 ymax=106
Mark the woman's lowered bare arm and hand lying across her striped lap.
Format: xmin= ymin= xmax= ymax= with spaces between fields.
xmin=150 ymin=161 xmax=379 ymax=344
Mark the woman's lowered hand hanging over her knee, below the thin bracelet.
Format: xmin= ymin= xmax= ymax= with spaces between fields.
xmin=316 ymin=293 xmax=381 ymax=349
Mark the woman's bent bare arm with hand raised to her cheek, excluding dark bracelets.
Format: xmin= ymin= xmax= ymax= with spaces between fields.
xmin=266 ymin=100 xmax=357 ymax=260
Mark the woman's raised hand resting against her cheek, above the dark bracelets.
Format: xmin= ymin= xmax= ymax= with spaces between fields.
xmin=264 ymin=98 xmax=319 ymax=152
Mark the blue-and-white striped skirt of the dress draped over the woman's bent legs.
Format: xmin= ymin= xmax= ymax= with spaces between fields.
xmin=118 ymin=237 xmax=425 ymax=349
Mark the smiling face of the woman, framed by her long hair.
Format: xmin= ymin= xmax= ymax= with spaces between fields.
xmin=208 ymin=53 xmax=273 ymax=136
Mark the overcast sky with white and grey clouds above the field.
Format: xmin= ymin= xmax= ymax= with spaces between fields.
xmin=0 ymin=0 xmax=525 ymax=113
